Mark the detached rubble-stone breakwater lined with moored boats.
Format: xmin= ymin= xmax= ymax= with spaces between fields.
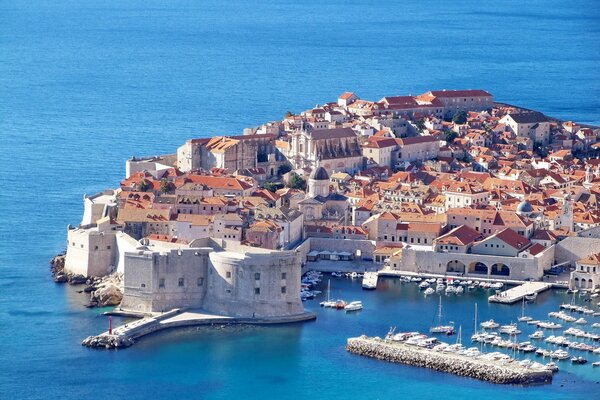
xmin=346 ymin=336 xmax=552 ymax=385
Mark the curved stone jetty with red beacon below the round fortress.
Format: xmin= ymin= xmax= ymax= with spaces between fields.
xmin=81 ymin=309 xmax=316 ymax=349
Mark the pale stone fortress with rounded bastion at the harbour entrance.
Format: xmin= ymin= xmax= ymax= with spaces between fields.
xmin=65 ymin=191 xmax=313 ymax=320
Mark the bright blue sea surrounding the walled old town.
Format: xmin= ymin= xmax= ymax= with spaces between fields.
xmin=0 ymin=0 xmax=600 ymax=400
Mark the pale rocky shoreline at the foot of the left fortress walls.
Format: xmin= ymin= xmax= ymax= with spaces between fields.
xmin=50 ymin=253 xmax=123 ymax=307
